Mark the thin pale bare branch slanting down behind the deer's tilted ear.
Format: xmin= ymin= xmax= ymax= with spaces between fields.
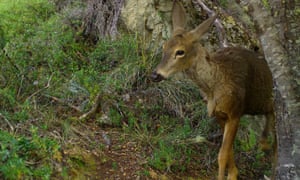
xmin=193 ymin=0 xmax=228 ymax=47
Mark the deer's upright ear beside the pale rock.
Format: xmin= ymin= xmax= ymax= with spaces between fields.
xmin=172 ymin=0 xmax=186 ymax=32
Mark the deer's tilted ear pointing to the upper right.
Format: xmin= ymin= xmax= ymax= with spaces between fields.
xmin=188 ymin=14 xmax=218 ymax=41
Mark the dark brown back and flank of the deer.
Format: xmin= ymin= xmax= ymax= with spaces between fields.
xmin=212 ymin=47 xmax=273 ymax=114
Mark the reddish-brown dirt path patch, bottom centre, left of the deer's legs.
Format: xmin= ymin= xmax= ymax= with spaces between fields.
xmin=54 ymin=122 xmax=164 ymax=180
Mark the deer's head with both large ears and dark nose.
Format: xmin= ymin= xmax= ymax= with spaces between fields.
xmin=151 ymin=1 xmax=216 ymax=81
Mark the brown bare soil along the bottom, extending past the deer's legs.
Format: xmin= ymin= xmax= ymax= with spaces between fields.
xmin=53 ymin=118 xmax=270 ymax=180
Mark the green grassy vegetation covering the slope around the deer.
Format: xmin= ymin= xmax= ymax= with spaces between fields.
xmin=0 ymin=0 xmax=274 ymax=179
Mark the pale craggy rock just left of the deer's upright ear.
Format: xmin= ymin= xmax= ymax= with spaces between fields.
xmin=121 ymin=0 xmax=172 ymax=44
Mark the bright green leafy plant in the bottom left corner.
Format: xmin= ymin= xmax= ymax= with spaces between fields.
xmin=0 ymin=127 xmax=60 ymax=179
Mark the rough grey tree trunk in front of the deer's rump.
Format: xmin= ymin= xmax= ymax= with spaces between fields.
xmin=248 ymin=0 xmax=300 ymax=179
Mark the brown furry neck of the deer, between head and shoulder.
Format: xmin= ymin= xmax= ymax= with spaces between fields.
xmin=186 ymin=47 xmax=217 ymax=98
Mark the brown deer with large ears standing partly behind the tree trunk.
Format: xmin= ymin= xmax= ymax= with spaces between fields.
xmin=151 ymin=1 xmax=276 ymax=180
